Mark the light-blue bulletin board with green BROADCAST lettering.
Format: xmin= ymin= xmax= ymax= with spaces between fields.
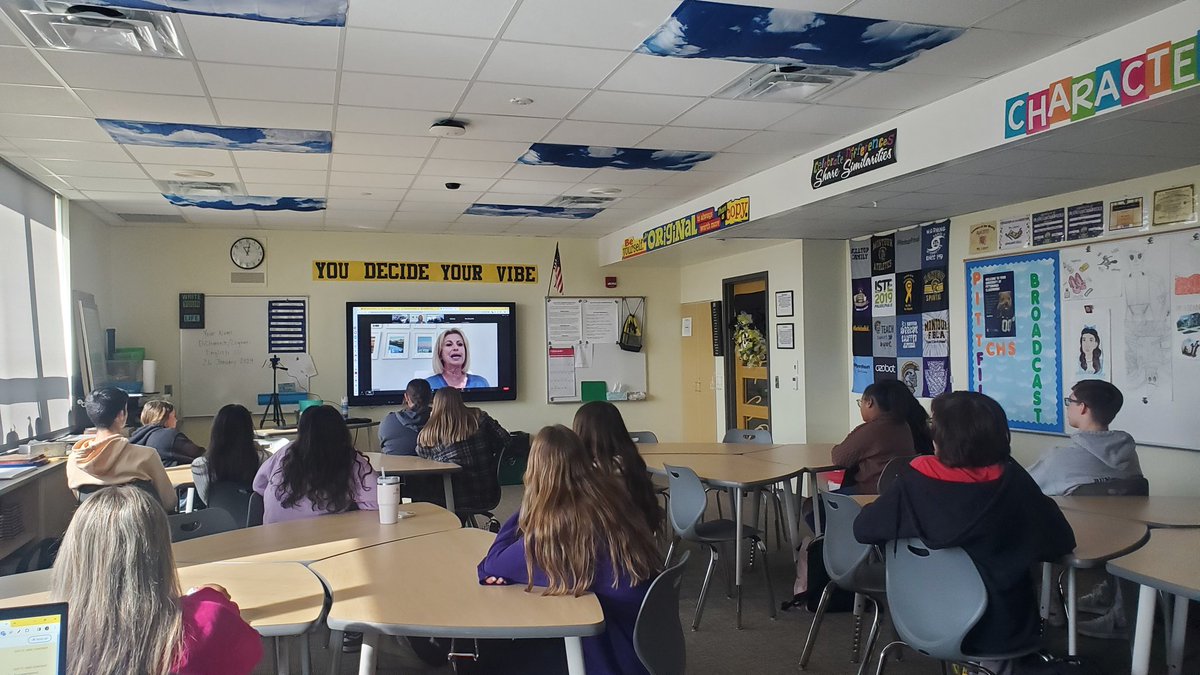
xmin=966 ymin=251 xmax=1063 ymax=432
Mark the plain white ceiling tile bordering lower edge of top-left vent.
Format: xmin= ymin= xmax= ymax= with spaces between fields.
xmin=40 ymin=49 xmax=204 ymax=96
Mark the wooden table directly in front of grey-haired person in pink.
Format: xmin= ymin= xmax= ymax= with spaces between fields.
xmin=0 ymin=562 xmax=325 ymax=674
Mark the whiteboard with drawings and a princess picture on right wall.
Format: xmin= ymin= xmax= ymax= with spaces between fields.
xmin=1058 ymin=229 xmax=1200 ymax=450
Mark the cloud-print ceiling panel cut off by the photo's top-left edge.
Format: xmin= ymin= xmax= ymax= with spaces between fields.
xmin=88 ymin=0 xmax=349 ymax=25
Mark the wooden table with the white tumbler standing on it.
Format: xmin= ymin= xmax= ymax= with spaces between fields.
xmin=172 ymin=502 xmax=461 ymax=565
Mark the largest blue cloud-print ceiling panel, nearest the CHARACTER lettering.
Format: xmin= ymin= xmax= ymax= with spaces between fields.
xmin=637 ymin=0 xmax=964 ymax=71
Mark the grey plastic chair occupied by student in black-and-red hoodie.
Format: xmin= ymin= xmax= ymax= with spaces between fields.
xmin=875 ymin=539 xmax=1038 ymax=675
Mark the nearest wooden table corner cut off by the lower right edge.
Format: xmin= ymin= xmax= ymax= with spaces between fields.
xmin=1108 ymin=528 xmax=1200 ymax=675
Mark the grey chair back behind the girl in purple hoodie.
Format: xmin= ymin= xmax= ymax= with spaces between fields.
xmin=634 ymin=551 xmax=691 ymax=675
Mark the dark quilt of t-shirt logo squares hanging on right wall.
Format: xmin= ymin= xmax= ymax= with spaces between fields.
xmin=850 ymin=221 xmax=950 ymax=396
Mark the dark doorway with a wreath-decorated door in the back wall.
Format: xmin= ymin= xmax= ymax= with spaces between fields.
xmin=722 ymin=271 xmax=770 ymax=431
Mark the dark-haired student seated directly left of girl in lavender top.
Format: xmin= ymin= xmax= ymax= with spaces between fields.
xmin=192 ymin=404 xmax=270 ymax=503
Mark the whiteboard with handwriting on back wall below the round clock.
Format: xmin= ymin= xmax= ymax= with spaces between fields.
xmin=179 ymin=295 xmax=312 ymax=417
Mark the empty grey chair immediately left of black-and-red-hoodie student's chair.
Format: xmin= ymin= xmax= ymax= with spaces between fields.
xmin=800 ymin=492 xmax=887 ymax=675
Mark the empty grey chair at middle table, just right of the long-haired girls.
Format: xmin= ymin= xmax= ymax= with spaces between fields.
xmin=664 ymin=465 xmax=775 ymax=631
